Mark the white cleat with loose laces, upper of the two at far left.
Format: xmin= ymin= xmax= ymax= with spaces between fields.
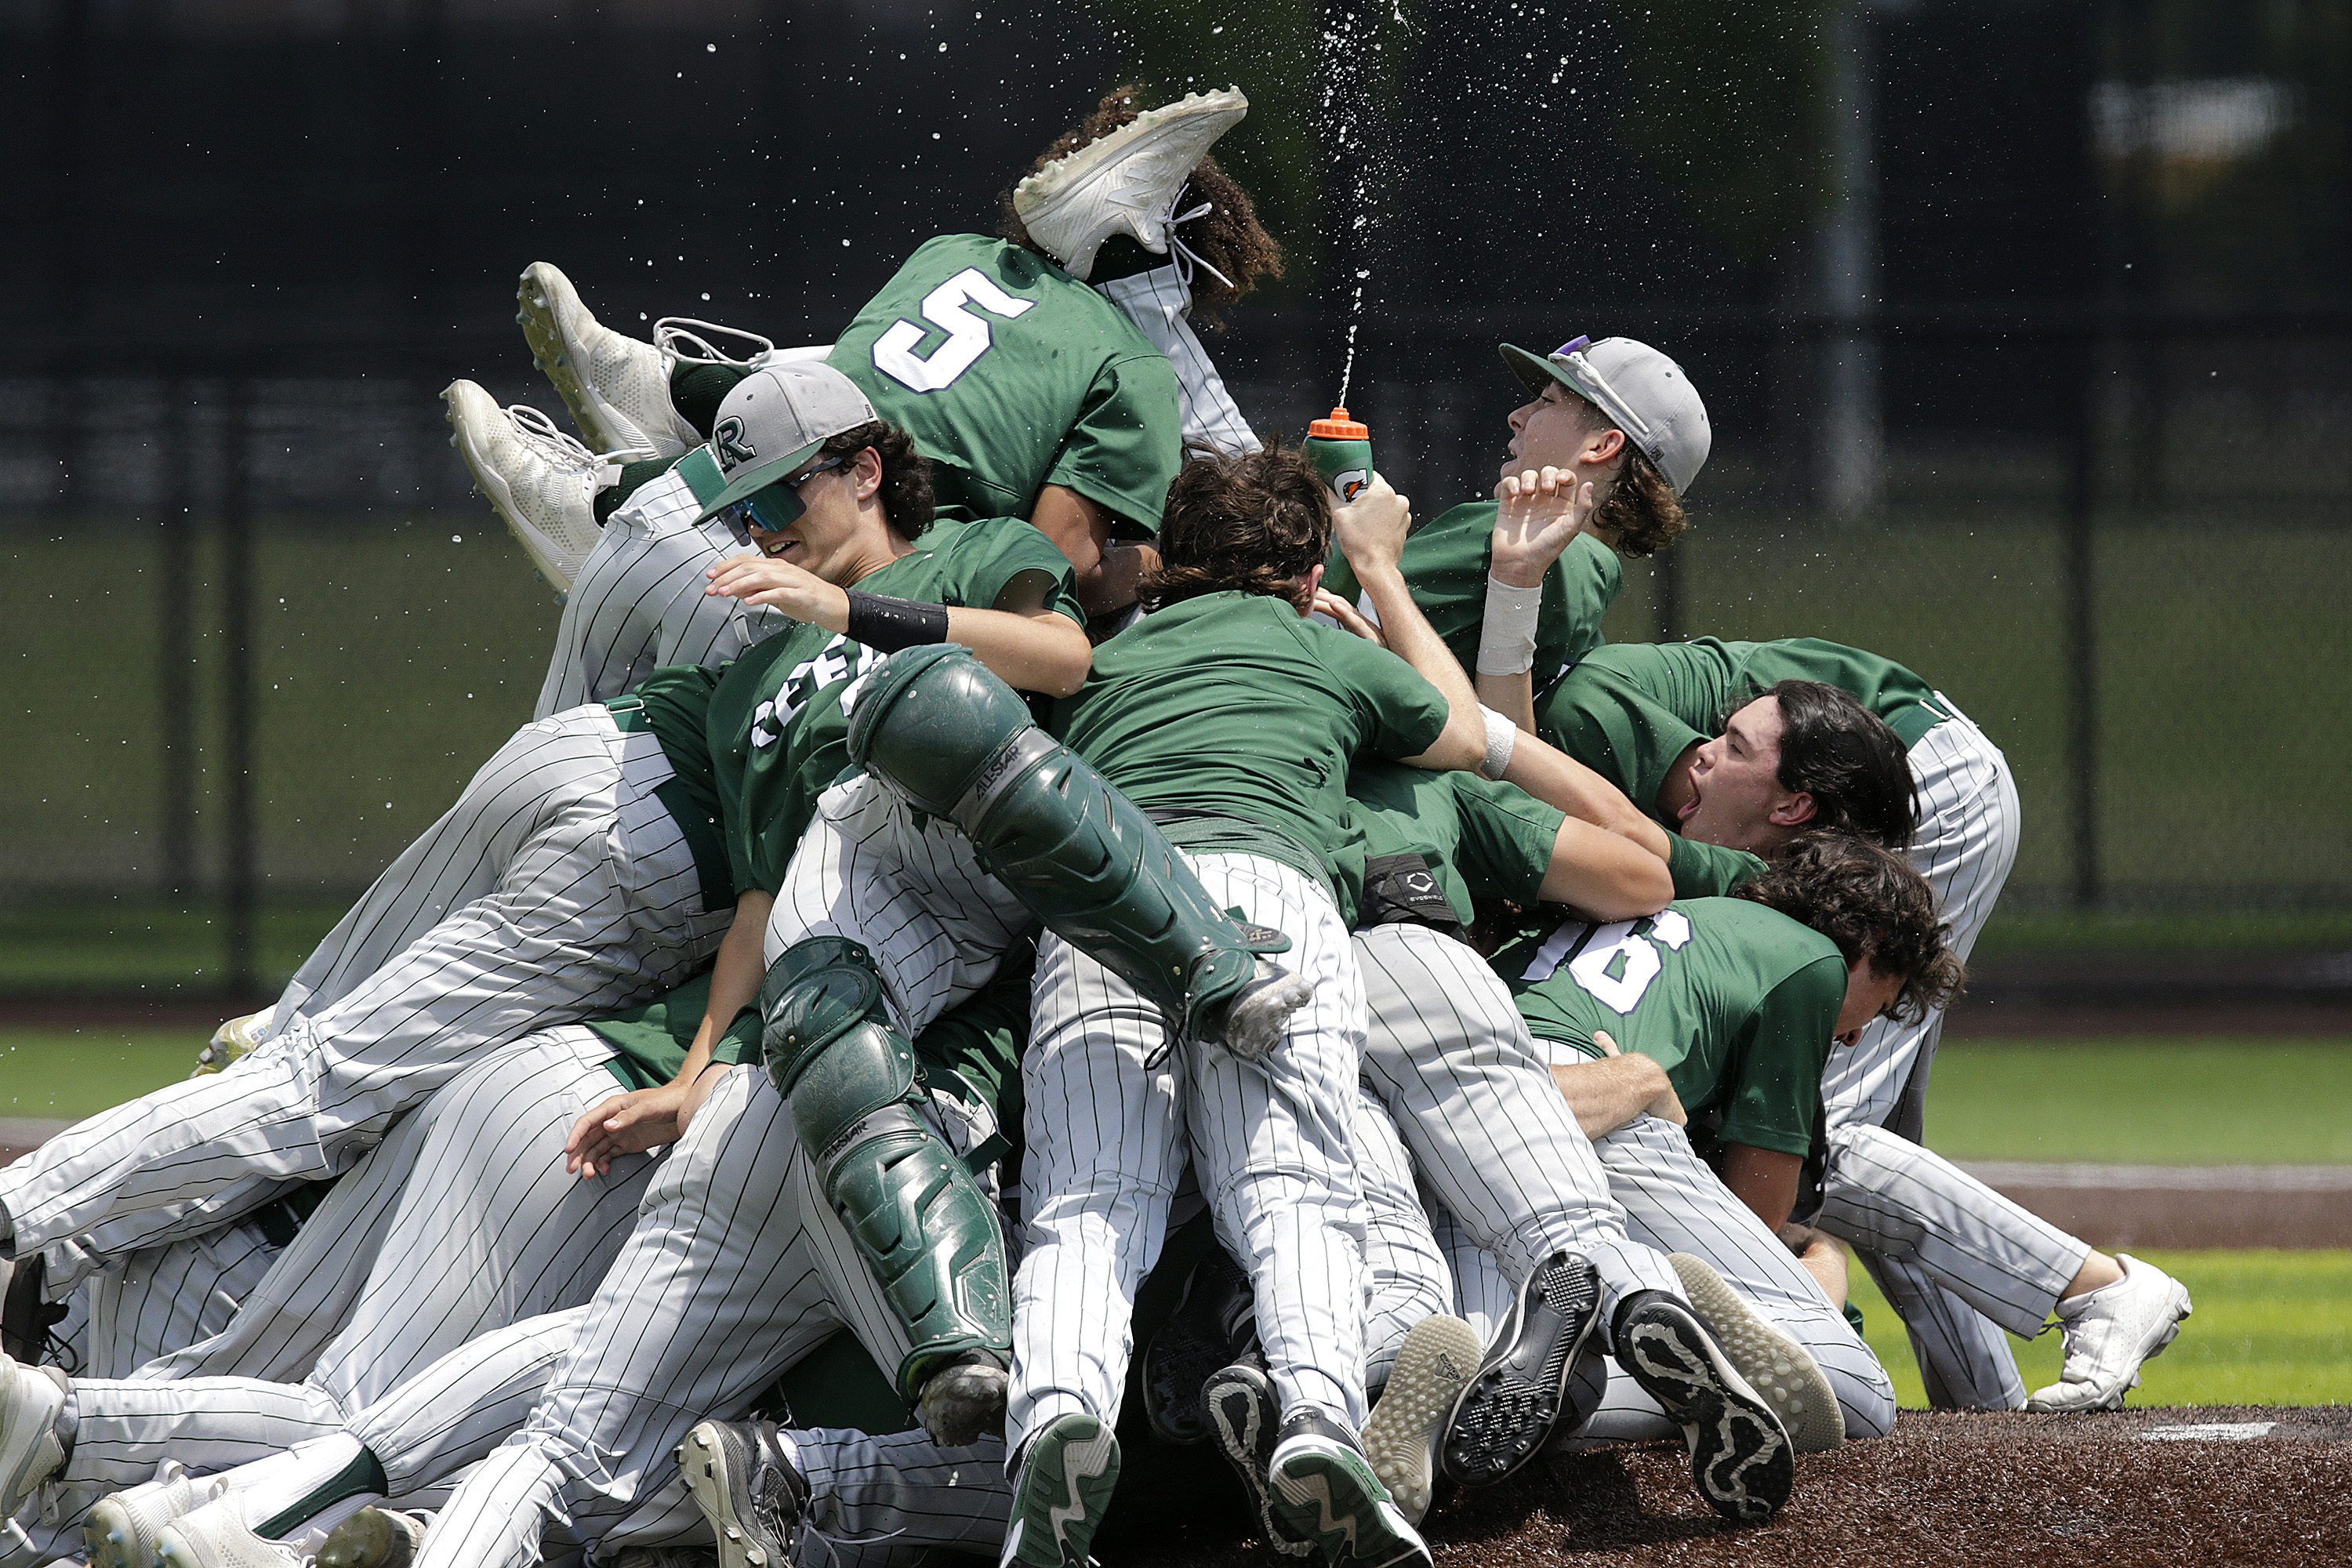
xmin=515 ymin=261 xmax=703 ymax=459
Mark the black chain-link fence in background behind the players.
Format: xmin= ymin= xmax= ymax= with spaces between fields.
xmin=0 ymin=0 xmax=2352 ymax=992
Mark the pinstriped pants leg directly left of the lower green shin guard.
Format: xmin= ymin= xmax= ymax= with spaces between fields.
xmin=400 ymin=1067 xmax=906 ymax=1568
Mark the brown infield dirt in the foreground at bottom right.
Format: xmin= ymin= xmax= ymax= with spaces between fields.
xmin=1096 ymin=1406 xmax=2352 ymax=1568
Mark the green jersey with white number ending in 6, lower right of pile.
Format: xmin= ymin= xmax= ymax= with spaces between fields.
xmin=1494 ymin=898 xmax=1846 ymax=1156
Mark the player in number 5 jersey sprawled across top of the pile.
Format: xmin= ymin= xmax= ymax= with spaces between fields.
xmin=447 ymin=89 xmax=1282 ymax=713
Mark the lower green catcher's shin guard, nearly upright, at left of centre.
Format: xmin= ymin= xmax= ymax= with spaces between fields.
xmin=760 ymin=935 xmax=1011 ymax=1401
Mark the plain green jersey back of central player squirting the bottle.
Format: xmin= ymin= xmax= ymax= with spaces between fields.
xmin=1054 ymin=593 xmax=1446 ymax=877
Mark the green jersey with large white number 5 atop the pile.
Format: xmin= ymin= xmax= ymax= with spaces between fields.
xmin=828 ymin=235 xmax=1183 ymax=536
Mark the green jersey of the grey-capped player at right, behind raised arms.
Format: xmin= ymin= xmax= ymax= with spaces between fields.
xmin=1324 ymin=501 xmax=1625 ymax=687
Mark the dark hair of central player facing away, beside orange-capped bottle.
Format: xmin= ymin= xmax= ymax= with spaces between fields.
xmin=1143 ymin=435 xmax=1331 ymax=609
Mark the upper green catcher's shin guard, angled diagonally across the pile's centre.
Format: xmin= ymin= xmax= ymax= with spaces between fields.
xmin=849 ymin=642 xmax=1308 ymax=1058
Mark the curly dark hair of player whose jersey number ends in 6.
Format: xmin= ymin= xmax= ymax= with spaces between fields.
xmin=1731 ymin=832 xmax=1969 ymax=1022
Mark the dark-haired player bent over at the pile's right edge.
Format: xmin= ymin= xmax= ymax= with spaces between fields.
xmin=1541 ymin=637 xmax=2190 ymax=1410
